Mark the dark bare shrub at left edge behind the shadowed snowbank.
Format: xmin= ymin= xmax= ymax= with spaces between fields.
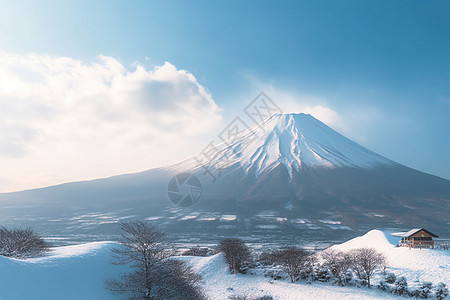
xmin=0 ymin=227 xmax=49 ymax=258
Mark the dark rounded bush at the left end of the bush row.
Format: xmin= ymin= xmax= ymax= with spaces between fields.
xmin=219 ymin=239 xmax=252 ymax=274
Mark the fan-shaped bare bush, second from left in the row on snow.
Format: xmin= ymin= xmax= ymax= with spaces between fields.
xmin=271 ymin=247 xmax=309 ymax=282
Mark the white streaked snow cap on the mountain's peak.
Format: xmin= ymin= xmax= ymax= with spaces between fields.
xmin=188 ymin=113 xmax=393 ymax=177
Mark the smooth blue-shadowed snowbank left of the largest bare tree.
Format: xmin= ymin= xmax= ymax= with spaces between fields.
xmin=0 ymin=242 xmax=124 ymax=300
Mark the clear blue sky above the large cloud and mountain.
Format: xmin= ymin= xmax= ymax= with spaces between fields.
xmin=0 ymin=0 xmax=450 ymax=190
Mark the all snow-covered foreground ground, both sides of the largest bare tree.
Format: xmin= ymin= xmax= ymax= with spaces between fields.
xmin=0 ymin=230 xmax=450 ymax=300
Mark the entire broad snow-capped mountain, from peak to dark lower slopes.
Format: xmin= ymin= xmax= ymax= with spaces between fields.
xmin=0 ymin=114 xmax=450 ymax=239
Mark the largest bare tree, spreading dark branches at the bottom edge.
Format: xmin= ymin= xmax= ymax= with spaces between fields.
xmin=106 ymin=221 xmax=204 ymax=300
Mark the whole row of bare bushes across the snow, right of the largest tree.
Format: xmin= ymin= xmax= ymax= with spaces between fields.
xmin=219 ymin=239 xmax=386 ymax=288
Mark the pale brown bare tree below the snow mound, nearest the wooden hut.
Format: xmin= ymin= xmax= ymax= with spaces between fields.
xmin=350 ymin=248 xmax=386 ymax=289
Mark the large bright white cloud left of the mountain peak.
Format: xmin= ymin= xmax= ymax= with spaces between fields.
xmin=0 ymin=53 xmax=221 ymax=191
